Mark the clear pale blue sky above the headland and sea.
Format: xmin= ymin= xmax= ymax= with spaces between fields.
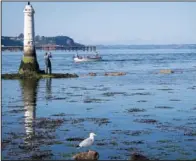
xmin=2 ymin=2 xmax=196 ymax=45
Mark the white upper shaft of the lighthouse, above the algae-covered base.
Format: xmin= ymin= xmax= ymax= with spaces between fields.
xmin=23 ymin=2 xmax=35 ymax=56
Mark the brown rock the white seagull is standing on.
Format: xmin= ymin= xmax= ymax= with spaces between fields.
xmin=73 ymin=150 xmax=99 ymax=160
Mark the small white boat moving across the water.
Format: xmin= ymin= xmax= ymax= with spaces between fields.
xmin=73 ymin=53 xmax=102 ymax=62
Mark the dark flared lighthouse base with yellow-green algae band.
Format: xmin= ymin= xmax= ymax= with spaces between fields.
xmin=19 ymin=56 xmax=41 ymax=74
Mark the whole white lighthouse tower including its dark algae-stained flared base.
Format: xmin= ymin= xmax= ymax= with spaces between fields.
xmin=19 ymin=2 xmax=40 ymax=74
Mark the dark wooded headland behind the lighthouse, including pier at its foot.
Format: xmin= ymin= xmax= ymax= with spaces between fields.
xmin=1 ymin=33 xmax=96 ymax=51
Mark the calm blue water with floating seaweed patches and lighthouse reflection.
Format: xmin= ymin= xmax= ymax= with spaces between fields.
xmin=2 ymin=49 xmax=196 ymax=160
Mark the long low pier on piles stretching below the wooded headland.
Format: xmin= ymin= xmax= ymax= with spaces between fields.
xmin=1 ymin=45 xmax=96 ymax=51
